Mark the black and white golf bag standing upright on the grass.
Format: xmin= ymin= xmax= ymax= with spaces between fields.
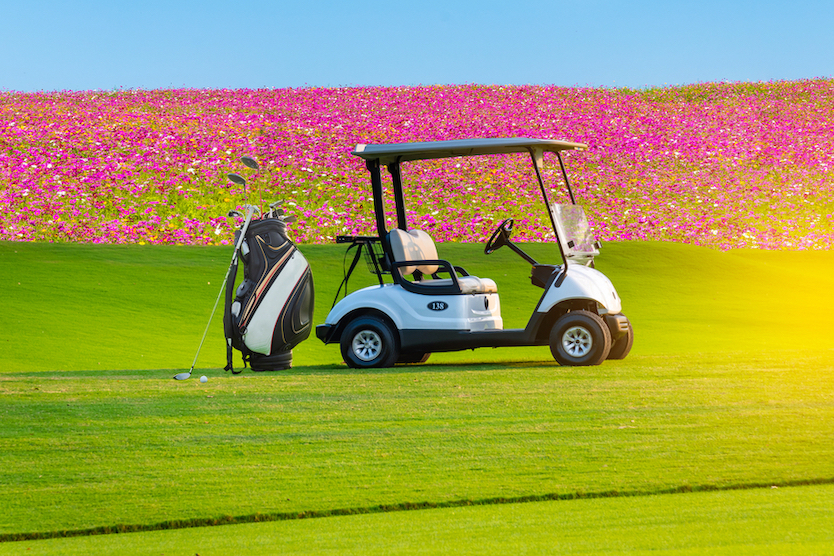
xmin=223 ymin=212 xmax=314 ymax=374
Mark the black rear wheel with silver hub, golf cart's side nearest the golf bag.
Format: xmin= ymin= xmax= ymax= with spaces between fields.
xmin=340 ymin=317 xmax=400 ymax=369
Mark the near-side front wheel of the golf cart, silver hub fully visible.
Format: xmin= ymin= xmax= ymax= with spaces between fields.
xmin=550 ymin=310 xmax=611 ymax=366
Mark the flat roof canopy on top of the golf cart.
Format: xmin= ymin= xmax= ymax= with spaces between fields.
xmin=351 ymin=137 xmax=588 ymax=165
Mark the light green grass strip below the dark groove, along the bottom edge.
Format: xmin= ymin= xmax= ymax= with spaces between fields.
xmin=0 ymin=486 xmax=834 ymax=556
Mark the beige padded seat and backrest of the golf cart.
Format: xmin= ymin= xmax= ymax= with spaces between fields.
xmin=388 ymin=228 xmax=498 ymax=293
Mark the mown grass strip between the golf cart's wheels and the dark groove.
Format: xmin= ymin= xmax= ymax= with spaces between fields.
xmin=0 ymin=355 xmax=834 ymax=533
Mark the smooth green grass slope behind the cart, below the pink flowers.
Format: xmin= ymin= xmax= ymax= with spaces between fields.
xmin=0 ymin=242 xmax=834 ymax=372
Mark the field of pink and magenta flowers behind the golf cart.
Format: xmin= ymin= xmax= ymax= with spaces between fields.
xmin=0 ymin=79 xmax=834 ymax=249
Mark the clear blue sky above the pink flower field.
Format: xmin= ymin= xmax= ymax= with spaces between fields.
xmin=0 ymin=0 xmax=834 ymax=92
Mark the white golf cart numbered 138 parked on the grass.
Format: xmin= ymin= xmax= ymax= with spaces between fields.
xmin=316 ymin=138 xmax=634 ymax=368
